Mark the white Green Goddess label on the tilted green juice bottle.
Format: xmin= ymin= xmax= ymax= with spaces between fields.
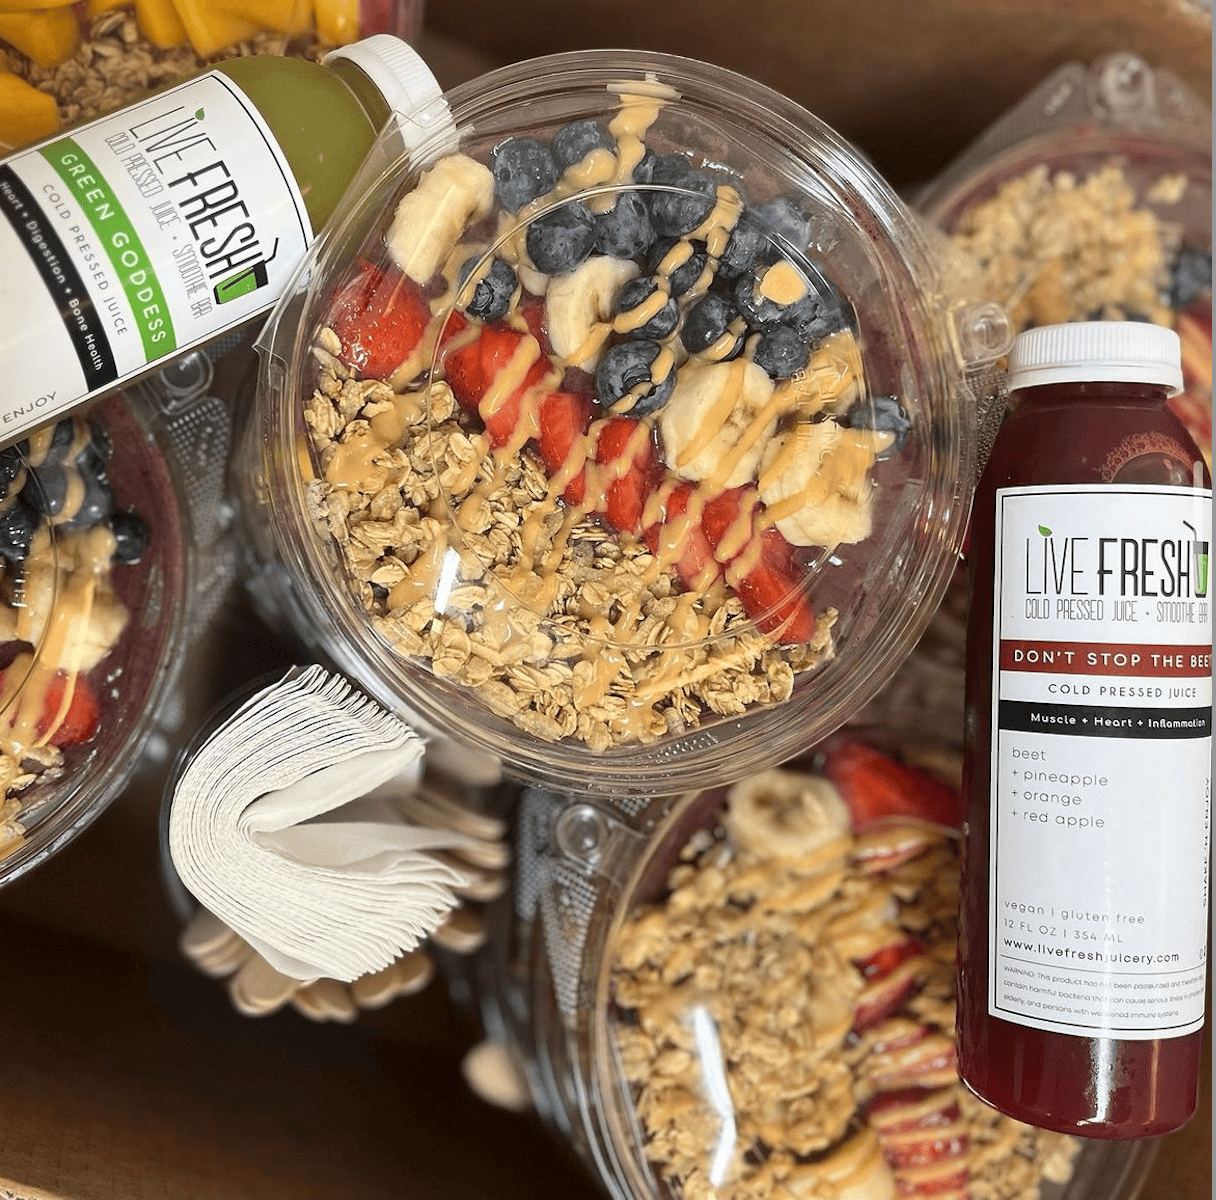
xmin=0 ymin=72 xmax=313 ymax=443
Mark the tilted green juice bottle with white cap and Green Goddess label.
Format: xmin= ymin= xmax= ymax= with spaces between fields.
xmin=0 ymin=34 xmax=446 ymax=444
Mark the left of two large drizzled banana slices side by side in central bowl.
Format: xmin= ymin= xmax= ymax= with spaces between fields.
xmin=659 ymin=359 xmax=781 ymax=490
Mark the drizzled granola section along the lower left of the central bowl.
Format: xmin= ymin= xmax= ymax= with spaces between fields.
xmin=304 ymin=329 xmax=835 ymax=750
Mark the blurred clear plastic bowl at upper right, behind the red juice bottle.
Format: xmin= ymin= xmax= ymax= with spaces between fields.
xmin=916 ymin=52 xmax=1212 ymax=463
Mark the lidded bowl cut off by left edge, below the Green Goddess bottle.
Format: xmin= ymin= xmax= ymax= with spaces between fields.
xmin=0 ymin=393 xmax=190 ymax=884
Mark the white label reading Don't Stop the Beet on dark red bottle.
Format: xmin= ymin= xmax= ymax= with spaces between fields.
xmin=989 ymin=485 xmax=1212 ymax=1040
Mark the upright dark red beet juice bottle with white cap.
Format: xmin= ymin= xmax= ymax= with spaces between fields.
xmin=958 ymin=322 xmax=1212 ymax=1138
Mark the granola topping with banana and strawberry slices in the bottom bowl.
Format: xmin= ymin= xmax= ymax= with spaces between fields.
xmin=612 ymin=771 xmax=1076 ymax=1200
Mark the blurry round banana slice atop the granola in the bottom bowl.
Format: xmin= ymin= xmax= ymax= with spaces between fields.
xmin=724 ymin=768 xmax=850 ymax=858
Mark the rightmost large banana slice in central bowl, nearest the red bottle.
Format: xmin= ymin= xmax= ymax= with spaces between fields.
xmin=758 ymin=419 xmax=880 ymax=547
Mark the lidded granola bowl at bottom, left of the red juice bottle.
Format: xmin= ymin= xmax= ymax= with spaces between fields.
xmin=478 ymin=724 xmax=1148 ymax=1200
